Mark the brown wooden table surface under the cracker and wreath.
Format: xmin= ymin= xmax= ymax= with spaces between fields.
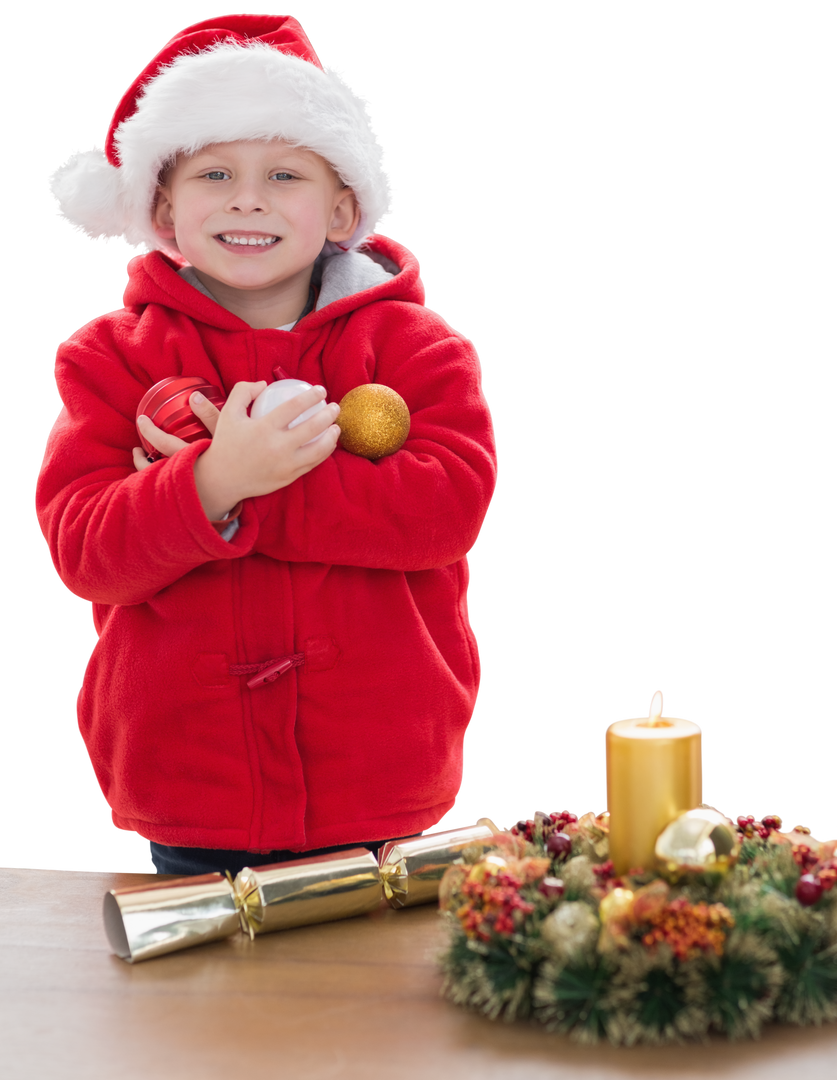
xmin=0 ymin=867 xmax=837 ymax=1080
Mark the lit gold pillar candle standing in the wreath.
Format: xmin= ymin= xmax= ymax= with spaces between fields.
xmin=603 ymin=688 xmax=706 ymax=875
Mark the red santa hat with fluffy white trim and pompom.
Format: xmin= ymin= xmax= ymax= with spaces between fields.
xmin=46 ymin=12 xmax=397 ymax=254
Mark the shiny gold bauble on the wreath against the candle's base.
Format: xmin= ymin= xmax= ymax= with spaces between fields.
xmin=654 ymin=809 xmax=740 ymax=881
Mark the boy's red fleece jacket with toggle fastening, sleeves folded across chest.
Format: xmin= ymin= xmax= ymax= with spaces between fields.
xmin=35 ymin=234 xmax=499 ymax=851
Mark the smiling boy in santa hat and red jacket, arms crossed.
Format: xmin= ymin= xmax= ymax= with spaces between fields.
xmin=35 ymin=13 xmax=498 ymax=874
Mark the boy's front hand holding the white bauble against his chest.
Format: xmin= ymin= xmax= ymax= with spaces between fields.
xmin=194 ymin=381 xmax=340 ymax=522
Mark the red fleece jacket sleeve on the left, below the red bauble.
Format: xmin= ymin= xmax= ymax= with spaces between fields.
xmin=33 ymin=327 xmax=258 ymax=605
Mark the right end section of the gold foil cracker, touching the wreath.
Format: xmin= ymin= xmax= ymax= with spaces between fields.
xmin=378 ymin=825 xmax=495 ymax=907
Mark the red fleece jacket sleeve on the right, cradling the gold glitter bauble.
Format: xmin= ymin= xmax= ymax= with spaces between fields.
xmin=248 ymin=303 xmax=499 ymax=571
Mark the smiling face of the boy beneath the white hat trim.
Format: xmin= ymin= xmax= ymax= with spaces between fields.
xmin=153 ymin=139 xmax=360 ymax=300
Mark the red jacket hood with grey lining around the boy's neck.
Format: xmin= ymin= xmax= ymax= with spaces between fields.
xmin=121 ymin=233 xmax=428 ymax=330
